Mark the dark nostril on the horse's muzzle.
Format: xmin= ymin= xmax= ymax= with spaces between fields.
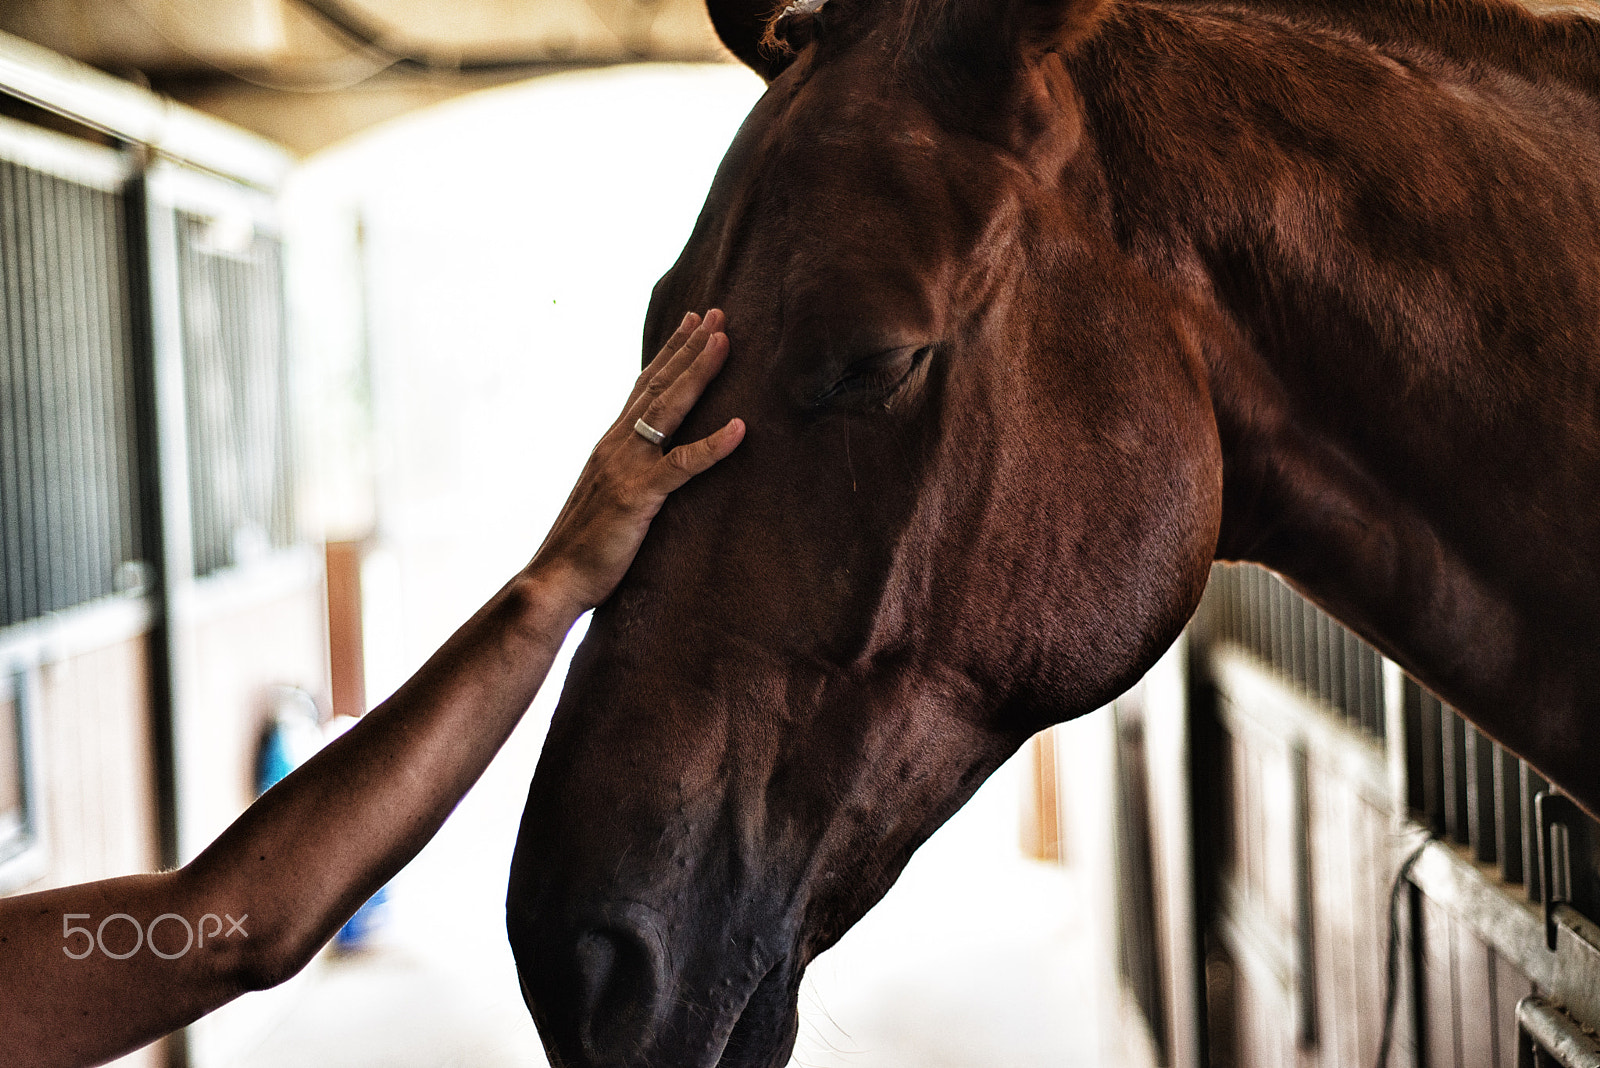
xmin=574 ymin=927 xmax=662 ymax=1065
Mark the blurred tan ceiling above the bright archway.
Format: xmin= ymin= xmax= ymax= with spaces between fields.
xmin=0 ymin=0 xmax=728 ymax=153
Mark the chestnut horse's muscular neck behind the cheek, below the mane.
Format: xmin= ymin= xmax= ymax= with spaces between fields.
xmin=1074 ymin=0 xmax=1600 ymax=783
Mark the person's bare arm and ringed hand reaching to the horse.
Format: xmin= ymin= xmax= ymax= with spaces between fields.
xmin=0 ymin=310 xmax=744 ymax=1066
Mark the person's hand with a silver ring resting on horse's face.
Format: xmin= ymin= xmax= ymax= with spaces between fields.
xmin=528 ymin=309 xmax=744 ymax=614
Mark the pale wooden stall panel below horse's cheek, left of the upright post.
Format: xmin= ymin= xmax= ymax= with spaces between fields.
xmin=1213 ymin=660 xmax=1397 ymax=1068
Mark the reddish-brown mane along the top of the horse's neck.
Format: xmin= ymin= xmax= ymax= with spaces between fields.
xmin=1184 ymin=0 xmax=1600 ymax=96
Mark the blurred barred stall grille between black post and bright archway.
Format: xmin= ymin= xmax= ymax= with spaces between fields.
xmin=178 ymin=213 xmax=296 ymax=577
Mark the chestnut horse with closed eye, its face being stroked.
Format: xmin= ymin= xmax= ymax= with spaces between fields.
xmin=507 ymin=0 xmax=1600 ymax=1068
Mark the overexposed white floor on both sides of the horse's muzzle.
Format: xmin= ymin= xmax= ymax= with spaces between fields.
xmin=230 ymin=629 xmax=1098 ymax=1068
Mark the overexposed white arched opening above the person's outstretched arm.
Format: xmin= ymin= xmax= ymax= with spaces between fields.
xmin=288 ymin=66 xmax=762 ymax=702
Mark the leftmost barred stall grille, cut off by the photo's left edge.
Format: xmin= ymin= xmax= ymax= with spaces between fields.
xmin=0 ymin=158 xmax=142 ymax=627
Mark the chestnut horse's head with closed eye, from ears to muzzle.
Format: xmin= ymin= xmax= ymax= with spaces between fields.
xmin=507 ymin=0 xmax=1221 ymax=1068
